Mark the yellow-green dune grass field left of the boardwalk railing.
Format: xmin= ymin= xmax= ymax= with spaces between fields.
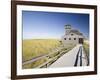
xmin=22 ymin=39 xmax=60 ymax=68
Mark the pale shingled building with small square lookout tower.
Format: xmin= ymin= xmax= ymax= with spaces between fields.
xmin=61 ymin=25 xmax=84 ymax=45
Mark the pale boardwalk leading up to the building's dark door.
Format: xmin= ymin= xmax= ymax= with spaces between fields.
xmin=49 ymin=44 xmax=88 ymax=68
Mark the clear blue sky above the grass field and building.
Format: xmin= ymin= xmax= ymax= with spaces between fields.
xmin=22 ymin=11 xmax=89 ymax=39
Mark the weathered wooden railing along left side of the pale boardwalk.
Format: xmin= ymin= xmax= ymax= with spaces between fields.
xmin=22 ymin=45 xmax=75 ymax=68
